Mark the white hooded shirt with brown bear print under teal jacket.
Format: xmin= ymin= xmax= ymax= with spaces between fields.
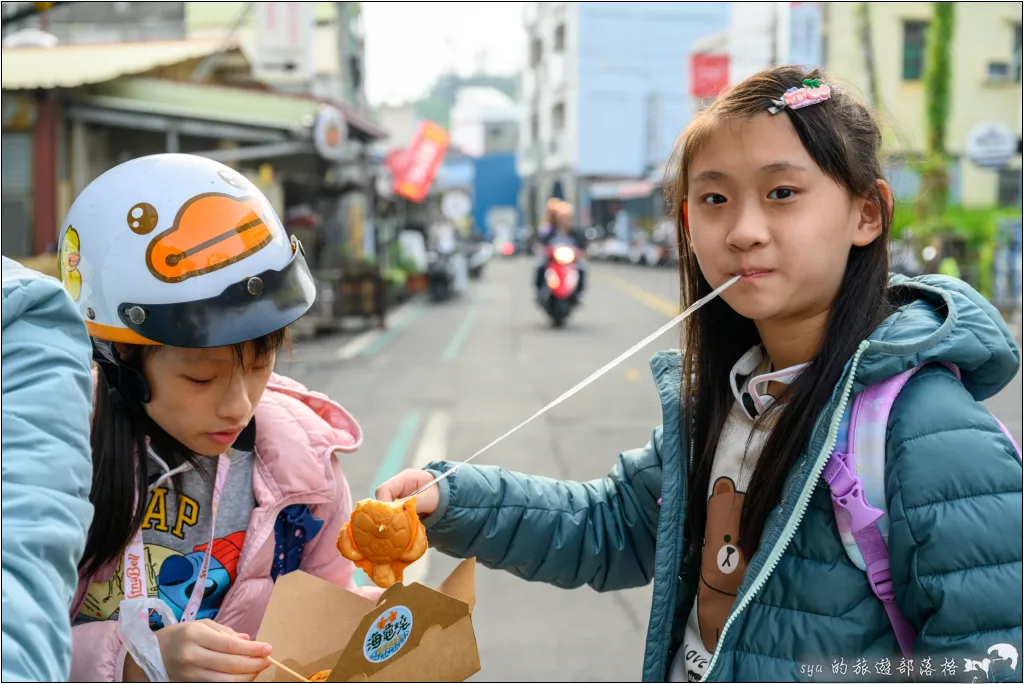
xmin=669 ymin=350 xmax=770 ymax=682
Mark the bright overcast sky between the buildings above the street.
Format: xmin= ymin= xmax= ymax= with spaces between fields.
xmin=362 ymin=2 xmax=526 ymax=104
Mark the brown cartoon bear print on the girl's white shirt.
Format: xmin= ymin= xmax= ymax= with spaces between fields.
xmin=697 ymin=477 xmax=746 ymax=653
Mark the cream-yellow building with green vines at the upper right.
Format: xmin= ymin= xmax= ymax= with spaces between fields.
xmin=822 ymin=2 xmax=1022 ymax=208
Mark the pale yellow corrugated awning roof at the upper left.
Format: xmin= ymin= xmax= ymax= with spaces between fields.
xmin=0 ymin=39 xmax=238 ymax=90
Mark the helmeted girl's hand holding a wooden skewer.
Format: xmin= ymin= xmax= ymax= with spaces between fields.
xmin=124 ymin=619 xmax=271 ymax=682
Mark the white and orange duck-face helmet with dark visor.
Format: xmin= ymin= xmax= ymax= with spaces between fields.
xmin=59 ymin=155 xmax=315 ymax=347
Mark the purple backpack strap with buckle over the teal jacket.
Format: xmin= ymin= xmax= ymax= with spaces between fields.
xmin=821 ymin=364 xmax=1021 ymax=658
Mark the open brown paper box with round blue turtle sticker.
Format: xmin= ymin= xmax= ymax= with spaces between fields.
xmin=256 ymin=558 xmax=480 ymax=682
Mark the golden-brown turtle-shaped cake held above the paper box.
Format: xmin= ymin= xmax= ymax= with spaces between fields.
xmin=338 ymin=497 xmax=427 ymax=589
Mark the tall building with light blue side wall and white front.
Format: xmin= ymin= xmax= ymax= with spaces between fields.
xmin=518 ymin=2 xmax=729 ymax=225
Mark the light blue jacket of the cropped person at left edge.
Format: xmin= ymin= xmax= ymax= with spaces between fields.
xmin=0 ymin=256 xmax=92 ymax=682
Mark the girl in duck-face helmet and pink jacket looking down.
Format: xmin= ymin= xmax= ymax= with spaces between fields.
xmin=59 ymin=155 xmax=369 ymax=681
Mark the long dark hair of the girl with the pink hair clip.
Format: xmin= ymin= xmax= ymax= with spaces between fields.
xmin=666 ymin=67 xmax=892 ymax=559
